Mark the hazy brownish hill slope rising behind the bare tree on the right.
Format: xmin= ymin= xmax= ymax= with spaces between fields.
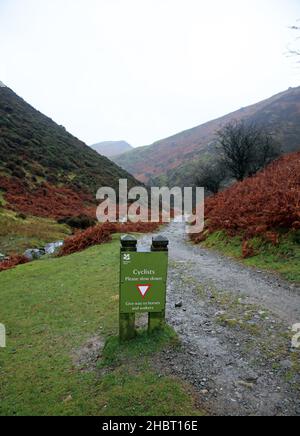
xmin=114 ymin=87 xmax=300 ymax=186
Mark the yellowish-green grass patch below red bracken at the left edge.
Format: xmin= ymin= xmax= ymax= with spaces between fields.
xmin=0 ymin=209 xmax=71 ymax=255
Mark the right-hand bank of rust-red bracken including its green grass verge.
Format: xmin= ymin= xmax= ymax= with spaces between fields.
xmin=192 ymin=152 xmax=300 ymax=281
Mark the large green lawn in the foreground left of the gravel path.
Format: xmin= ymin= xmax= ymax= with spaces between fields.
xmin=0 ymin=236 xmax=201 ymax=416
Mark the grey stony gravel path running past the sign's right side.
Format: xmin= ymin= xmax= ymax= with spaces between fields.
xmin=140 ymin=223 xmax=300 ymax=416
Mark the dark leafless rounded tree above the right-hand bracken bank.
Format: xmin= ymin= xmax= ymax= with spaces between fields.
xmin=217 ymin=121 xmax=280 ymax=181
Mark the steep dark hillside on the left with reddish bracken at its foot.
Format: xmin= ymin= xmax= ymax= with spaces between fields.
xmin=0 ymin=85 xmax=137 ymax=218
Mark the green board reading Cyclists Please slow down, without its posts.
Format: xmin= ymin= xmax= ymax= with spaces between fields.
xmin=120 ymin=252 xmax=168 ymax=314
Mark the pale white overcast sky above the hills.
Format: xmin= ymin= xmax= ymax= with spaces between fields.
xmin=0 ymin=0 xmax=300 ymax=146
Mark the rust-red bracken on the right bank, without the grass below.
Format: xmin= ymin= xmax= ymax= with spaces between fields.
xmin=192 ymin=152 xmax=300 ymax=245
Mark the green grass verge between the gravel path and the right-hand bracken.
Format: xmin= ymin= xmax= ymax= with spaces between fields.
xmin=203 ymin=231 xmax=300 ymax=283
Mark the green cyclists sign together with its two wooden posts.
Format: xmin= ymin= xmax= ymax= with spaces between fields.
xmin=120 ymin=235 xmax=169 ymax=341
